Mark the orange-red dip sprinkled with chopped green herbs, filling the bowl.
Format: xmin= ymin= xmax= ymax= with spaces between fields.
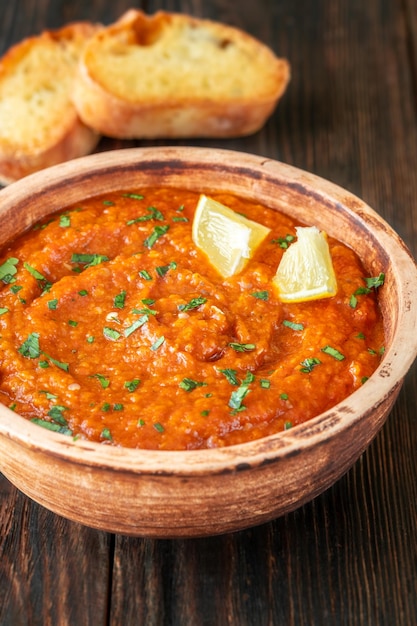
xmin=0 ymin=189 xmax=384 ymax=450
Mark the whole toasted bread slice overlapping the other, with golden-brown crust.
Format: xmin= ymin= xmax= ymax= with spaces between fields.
xmin=73 ymin=9 xmax=290 ymax=139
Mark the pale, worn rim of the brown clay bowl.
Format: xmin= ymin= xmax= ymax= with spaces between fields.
xmin=0 ymin=146 xmax=417 ymax=476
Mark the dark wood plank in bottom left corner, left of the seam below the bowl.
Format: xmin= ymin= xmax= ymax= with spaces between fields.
xmin=0 ymin=475 xmax=112 ymax=626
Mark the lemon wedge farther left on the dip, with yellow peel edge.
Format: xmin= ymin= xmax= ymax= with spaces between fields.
xmin=192 ymin=194 xmax=271 ymax=278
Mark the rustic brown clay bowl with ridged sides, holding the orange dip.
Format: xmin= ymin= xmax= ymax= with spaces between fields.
xmin=0 ymin=148 xmax=417 ymax=537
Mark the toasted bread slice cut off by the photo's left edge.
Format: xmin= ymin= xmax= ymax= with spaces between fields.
xmin=0 ymin=22 xmax=100 ymax=184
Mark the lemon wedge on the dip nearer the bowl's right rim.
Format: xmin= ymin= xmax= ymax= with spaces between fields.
xmin=273 ymin=226 xmax=337 ymax=302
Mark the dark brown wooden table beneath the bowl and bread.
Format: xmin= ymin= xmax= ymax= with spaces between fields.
xmin=0 ymin=0 xmax=417 ymax=626
